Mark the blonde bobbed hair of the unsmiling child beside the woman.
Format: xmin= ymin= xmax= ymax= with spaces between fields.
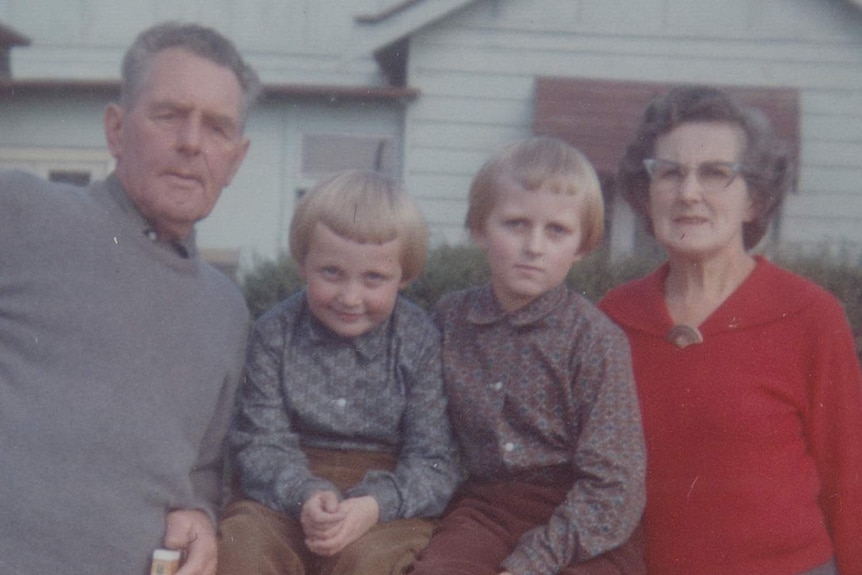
xmin=465 ymin=136 xmax=605 ymax=254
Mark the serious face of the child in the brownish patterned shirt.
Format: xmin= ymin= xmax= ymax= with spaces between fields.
xmin=473 ymin=184 xmax=582 ymax=312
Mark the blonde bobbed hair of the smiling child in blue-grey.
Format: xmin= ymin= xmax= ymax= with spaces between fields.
xmin=290 ymin=170 xmax=428 ymax=282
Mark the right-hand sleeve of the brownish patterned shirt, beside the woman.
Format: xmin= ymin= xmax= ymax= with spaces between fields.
xmin=503 ymin=331 xmax=646 ymax=575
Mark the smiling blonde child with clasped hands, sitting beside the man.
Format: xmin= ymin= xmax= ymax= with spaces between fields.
xmin=218 ymin=171 xmax=458 ymax=575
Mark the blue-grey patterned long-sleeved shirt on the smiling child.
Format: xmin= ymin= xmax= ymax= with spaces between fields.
xmin=230 ymin=291 xmax=458 ymax=521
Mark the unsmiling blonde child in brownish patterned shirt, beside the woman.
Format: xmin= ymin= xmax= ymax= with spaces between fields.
xmin=412 ymin=138 xmax=644 ymax=575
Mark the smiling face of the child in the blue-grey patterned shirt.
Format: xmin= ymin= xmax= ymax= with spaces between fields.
xmin=299 ymin=223 xmax=405 ymax=337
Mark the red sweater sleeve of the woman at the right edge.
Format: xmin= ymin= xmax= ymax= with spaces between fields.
xmin=806 ymin=298 xmax=862 ymax=575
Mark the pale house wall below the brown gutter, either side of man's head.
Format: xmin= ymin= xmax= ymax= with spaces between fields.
xmin=0 ymin=95 xmax=403 ymax=268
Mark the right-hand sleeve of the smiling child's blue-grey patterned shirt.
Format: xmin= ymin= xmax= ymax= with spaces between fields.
xmin=347 ymin=319 xmax=458 ymax=521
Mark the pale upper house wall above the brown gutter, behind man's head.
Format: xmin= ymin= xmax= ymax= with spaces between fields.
xmin=0 ymin=0 xmax=388 ymax=86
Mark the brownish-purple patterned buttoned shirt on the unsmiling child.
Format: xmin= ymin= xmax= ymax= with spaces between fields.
xmin=436 ymin=285 xmax=645 ymax=575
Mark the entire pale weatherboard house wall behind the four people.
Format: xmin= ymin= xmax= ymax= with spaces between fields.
xmin=0 ymin=0 xmax=862 ymax=262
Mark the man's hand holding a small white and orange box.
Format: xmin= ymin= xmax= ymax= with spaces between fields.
xmin=164 ymin=509 xmax=218 ymax=575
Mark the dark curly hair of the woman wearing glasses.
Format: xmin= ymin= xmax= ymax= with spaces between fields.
xmin=617 ymin=86 xmax=795 ymax=250
